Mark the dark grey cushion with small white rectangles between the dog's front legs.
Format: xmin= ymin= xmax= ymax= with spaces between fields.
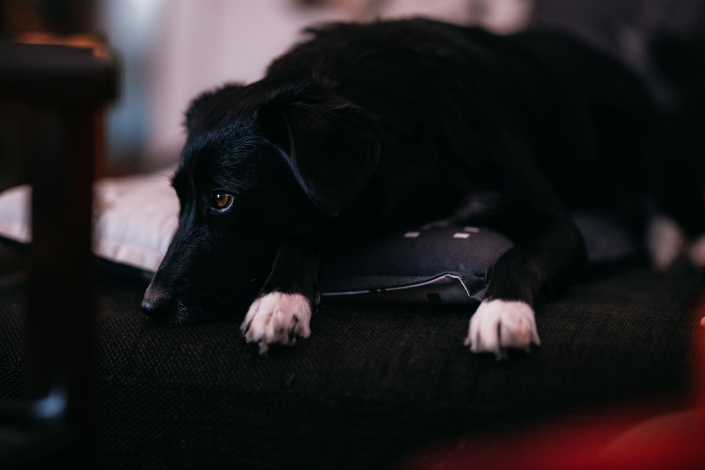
xmin=319 ymin=224 xmax=512 ymax=304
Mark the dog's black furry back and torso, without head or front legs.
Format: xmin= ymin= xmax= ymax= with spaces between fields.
xmin=269 ymin=20 xmax=688 ymax=237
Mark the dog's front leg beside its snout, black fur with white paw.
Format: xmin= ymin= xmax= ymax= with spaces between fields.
xmin=240 ymin=240 xmax=321 ymax=354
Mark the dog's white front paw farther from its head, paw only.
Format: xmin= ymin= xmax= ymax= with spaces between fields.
xmin=465 ymin=300 xmax=541 ymax=359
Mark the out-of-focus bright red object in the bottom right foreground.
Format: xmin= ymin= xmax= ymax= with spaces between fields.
xmin=397 ymin=291 xmax=705 ymax=470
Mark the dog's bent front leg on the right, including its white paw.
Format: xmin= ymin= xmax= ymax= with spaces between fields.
xmin=465 ymin=210 xmax=585 ymax=358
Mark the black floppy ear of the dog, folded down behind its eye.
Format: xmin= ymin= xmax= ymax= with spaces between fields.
xmin=258 ymin=83 xmax=380 ymax=216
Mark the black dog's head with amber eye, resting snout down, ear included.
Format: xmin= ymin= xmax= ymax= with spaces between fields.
xmin=142 ymin=81 xmax=379 ymax=323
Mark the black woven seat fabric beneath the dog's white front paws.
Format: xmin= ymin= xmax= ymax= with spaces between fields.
xmin=0 ymin=268 xmax=699 ymax=469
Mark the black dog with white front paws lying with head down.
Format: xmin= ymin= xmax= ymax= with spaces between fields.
xmin=142 ymin=20 xmax=700 ymax=354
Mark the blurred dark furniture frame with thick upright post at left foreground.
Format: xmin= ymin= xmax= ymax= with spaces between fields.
xmin=0 ymin=43 xmax=117 ymax=468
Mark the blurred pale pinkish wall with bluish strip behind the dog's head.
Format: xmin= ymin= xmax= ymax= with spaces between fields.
xmin=108 ymin=0 xmax=345 ymax=173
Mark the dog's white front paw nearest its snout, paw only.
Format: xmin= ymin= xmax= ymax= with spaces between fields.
xmin=240 ymin=292 xmax=311 ymax=354
